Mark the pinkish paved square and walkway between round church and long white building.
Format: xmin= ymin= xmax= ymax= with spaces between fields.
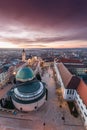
xmin=0 ymin=68 xmax=84 ymax=130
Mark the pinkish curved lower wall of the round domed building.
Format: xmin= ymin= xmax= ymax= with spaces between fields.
xmin=12 ymin=94 xmax=46 ymax=112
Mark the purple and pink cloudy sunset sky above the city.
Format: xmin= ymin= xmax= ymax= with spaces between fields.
xmin=0 ymin=0 xmax=87 ymax=48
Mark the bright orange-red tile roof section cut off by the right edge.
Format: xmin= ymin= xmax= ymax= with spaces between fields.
xmin=77 ymin=80 xmax=87 ymax=106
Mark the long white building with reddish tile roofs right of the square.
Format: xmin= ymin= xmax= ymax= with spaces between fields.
xmin=54 ymin=61 xmax=87 ymax=127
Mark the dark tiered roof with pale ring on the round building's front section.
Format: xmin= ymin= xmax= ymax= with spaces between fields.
xmin=13 ymin=81 xmax=45 ymax=103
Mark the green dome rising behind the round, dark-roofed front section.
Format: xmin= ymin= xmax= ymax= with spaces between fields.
xmin=16 ymin=67 xmax=34 ymax=82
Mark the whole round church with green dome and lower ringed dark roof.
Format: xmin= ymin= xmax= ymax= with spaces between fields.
xmin=11 ymin=67 xmax=47 ymax=112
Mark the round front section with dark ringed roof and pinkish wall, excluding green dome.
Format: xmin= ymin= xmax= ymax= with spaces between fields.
xmin=9 ymin=79 xmax=47 ymax=112
